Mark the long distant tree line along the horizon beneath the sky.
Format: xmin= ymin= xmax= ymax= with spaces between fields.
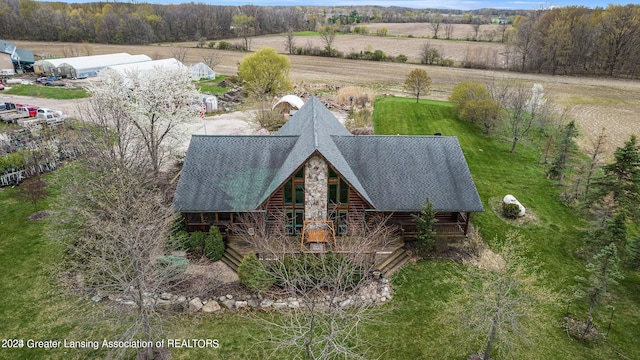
xmin=0 ymin=0 xmax=522 ymax=44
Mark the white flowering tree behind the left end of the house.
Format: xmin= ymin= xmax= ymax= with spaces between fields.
xmin=88 ymin=67 xmax=199 ymax=174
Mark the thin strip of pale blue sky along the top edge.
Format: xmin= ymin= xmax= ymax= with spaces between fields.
xmin=43 ymin=0 xmax=638 ymax=10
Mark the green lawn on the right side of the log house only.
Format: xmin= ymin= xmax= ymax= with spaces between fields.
xmin=374 ymin=98 xmax=640 ymax=359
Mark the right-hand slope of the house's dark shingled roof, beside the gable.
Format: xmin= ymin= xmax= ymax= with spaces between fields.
xmin=333 ymin=135 xmax=483 ymax=212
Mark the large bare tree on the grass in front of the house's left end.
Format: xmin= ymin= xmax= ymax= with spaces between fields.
xmin=51 ymin=165 xmax=186 ymax=359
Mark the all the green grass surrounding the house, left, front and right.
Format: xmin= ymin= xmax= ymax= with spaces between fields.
xmin=0 ymin=98 xmax=640 ymax=360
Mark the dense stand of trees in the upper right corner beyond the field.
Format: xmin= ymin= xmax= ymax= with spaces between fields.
xmin=508 ymin=4 xmax=640 ymax=78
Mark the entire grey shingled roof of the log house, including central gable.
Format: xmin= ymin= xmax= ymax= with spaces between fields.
xmin=174 ymin=97 xmax=483 ymax=212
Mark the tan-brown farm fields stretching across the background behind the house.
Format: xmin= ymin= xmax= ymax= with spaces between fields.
xmin=12 ymin=32 xmax=640 ymax=150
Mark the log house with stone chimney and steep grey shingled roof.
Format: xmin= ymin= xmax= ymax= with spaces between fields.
xmin=173 ymin=97 xmax=483 ymax=268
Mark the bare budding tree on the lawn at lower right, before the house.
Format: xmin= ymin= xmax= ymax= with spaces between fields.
xmin=439 ymin=232 xmax=558 ymax=359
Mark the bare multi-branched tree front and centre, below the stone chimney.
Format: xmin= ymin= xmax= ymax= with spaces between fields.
xmin=235 ymin=213 xmax=394 ymax=359
